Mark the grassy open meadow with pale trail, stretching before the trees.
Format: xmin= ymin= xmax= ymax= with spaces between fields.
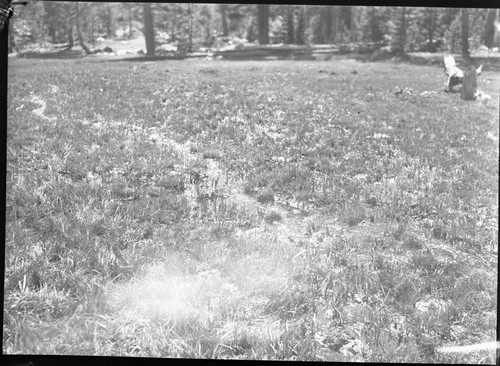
xmin=3 ymin=58 xmax=500 ymax=363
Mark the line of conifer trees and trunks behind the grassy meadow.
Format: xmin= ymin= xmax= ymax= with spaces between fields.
xmin=9 ymin=1 xmax=500 ymax=56
